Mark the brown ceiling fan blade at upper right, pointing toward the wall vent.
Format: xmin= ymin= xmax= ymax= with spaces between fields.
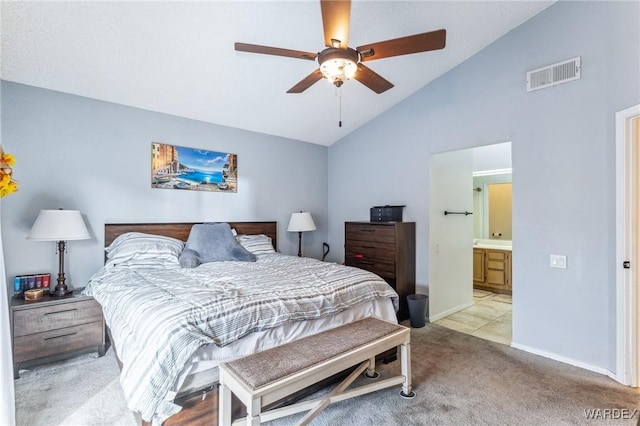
xmin=356 ymin=29 xmax=447 ymax=61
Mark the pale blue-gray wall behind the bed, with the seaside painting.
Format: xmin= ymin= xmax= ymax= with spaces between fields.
xmin=2 ymin=82 xmax=327 ymax=287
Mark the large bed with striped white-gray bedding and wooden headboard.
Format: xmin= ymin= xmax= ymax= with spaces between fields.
xmin=84 ymin=222 xmax=398 ymax=424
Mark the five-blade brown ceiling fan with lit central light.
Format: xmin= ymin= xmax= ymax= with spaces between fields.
xmin=235 ymin=0 xmax=447 ymax=93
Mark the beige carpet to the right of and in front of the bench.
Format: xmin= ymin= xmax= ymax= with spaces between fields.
xmin=268 ymin=324 xmax=640 ymax=426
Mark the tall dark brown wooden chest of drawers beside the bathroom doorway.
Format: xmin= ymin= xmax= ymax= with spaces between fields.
xmin=344 ymin=222 xmax=416 ymax=320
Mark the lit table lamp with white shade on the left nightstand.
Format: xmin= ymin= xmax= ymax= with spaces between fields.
xmin=27 ymin=209 xmax=91 ymax=296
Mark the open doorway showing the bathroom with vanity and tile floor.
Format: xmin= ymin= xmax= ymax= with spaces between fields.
xmin=429 ymin=142 xmax=513 ymax=344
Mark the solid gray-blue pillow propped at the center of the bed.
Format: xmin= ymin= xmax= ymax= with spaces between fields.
xmin=180 ymin=223 xmax=256 ymax=267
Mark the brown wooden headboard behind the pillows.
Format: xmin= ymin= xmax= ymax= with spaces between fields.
xmin=104 ymin=222 xmax=278 ymax=250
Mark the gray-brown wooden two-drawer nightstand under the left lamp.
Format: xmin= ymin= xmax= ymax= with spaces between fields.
xmin=10 ymin=289 xmax=106 ymax=379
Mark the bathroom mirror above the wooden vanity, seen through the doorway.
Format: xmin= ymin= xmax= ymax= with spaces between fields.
xmin=473 ymin=170 xmax=512 ymax=240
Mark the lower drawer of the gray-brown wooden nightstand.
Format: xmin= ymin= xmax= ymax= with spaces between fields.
xmin=13 ymin=318 xmax=103 ymax=362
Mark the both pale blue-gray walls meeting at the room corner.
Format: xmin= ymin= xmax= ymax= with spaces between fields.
xmin=1 ymin=1 xmax=640 ymax=376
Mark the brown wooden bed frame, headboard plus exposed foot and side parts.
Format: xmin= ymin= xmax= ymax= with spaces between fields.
xmin=104 ymin=222 xmax=278 ymax=426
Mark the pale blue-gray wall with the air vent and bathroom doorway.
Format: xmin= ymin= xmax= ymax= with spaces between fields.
xmin=329 ymin=1 xmax=640 ymax=371
